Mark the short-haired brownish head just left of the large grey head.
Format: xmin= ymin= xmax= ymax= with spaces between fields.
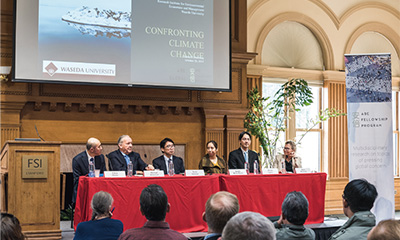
xmin=203 ymin=191 xmax=239 ymax=233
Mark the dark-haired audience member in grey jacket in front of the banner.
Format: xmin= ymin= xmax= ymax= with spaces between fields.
xmin=329 ymin=179 xmax=378 ymax=240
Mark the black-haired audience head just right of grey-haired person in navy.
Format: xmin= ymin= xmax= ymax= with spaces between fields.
xmin=140 ymin=184 xmax=169 ymax=221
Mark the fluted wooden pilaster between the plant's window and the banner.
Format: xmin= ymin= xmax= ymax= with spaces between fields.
xmin=327 ymin=82 xmax=349 ymax=179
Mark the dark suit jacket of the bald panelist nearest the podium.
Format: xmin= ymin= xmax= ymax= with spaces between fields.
xmin=72 ymin=151 xmax=106 ymax=203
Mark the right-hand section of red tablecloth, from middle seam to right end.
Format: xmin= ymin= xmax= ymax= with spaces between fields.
xmin=220 ymin=173 xmax=326 ymax=224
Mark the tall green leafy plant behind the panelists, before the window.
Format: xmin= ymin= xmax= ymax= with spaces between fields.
xmin=244 ymin=78 xmax=345 ymax=167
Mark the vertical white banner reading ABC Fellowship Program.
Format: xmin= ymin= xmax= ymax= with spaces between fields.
xmin=345 ymin=54 xmax=394 ymax=222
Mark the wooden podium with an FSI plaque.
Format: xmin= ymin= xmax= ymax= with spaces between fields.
xmin=0 ymin=141 xmax=61 ymax=239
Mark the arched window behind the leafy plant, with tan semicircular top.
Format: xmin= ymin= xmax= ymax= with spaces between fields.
xmin=261 ymin=21 xmax=324 ymax=171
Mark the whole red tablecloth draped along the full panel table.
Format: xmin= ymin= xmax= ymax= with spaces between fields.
xmin=74 ymin=173 xmax=326 ymax=232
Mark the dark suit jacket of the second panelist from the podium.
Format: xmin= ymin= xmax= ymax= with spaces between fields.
xmin=106 ymin=150 xmax=147 ymax=174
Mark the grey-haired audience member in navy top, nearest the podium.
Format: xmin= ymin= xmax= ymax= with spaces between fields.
xmin=74 ymin=191 xmax=124 ymax=240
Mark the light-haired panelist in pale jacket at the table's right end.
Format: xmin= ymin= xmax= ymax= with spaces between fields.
xmin=273 ymin=141 xmax=302 ymax=173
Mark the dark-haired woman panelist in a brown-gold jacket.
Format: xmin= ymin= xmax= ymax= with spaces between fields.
xmin=199 ymin=141 xmax=227 ymax=174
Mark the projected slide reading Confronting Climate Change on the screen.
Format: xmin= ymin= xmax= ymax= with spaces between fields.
xmin=15 ymin=0 xmax=230 ymax=90
